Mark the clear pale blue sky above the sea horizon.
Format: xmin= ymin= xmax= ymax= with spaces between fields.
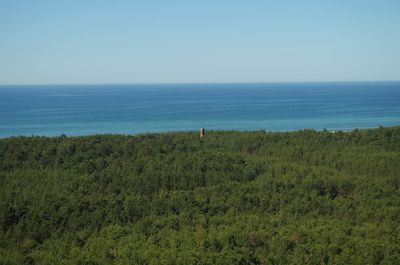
xmin=0 ymin=0 xmax=400 ymax=84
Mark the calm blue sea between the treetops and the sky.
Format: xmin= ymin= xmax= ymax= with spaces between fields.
xmin=0 ymin=82 xmax=400 ymax=137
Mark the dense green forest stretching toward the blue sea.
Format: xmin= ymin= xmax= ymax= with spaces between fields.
xmin=0 ymin=127 xmax=400 ymax=265
